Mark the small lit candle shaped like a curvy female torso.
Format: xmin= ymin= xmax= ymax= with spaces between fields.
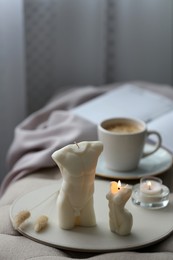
xmin=106 ymin=182 xmax=133 ymax=235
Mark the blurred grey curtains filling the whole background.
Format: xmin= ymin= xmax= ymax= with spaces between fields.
xmin=0 ymin=0 xmax=173 ymax=181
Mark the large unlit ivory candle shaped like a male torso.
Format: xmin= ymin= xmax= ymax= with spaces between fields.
xmin=52 ymin=141 xmax=103 ymax=229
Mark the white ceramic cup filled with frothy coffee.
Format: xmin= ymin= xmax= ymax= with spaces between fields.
xmin=98 ymin=118 xmax=161 ymax=171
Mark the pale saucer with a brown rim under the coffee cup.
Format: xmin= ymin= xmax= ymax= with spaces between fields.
xmin=96 ymin=144 xmax=173 ymax=180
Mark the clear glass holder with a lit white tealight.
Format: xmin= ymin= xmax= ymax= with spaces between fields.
xmin=132 ymin=177 xmax=170 ymax=209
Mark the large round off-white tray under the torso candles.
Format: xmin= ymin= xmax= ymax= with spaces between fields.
xmin=10 ymin=180 xmax=173 ymax=252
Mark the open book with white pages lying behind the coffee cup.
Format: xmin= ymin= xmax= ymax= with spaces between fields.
xmin=72 ymin=84 xmax=173 ymax=153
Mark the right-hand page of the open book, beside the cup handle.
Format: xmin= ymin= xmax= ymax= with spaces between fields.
xmin=148 ymin=111 xmax=173 ymax=153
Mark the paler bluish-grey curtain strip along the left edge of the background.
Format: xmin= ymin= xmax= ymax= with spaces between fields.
xmin=0 ymin=0 xmax=26 ymax=183
